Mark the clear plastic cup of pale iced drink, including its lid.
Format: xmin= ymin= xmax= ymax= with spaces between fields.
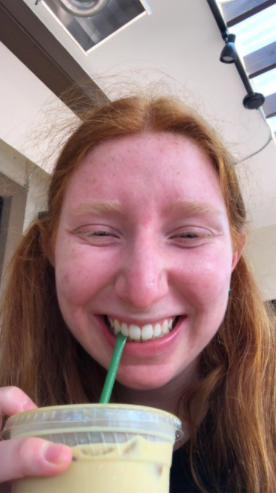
xmin=2 ymin=404 xmax=183 ymax=493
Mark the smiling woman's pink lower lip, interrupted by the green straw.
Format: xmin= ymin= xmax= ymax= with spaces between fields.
xmin=94 ymin=315 xmax=188 ymax=358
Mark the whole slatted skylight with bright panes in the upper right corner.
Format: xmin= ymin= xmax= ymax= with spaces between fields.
xmin=218 ymin=0 xmax=276 ymax=132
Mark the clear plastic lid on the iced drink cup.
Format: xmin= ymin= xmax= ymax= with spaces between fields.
xmin=2 ymin=404 xmax=183 ymax=441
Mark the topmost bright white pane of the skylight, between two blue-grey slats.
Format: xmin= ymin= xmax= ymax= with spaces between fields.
xmin=229 ymin=4 xmax=276 ymax=56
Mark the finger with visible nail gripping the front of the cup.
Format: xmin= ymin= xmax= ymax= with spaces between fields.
xmin=0 ymin=438 xmax=72 ymax=483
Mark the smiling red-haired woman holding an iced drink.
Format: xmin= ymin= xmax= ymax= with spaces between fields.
xmin=0 ymin=97 xmax=276 ymax=493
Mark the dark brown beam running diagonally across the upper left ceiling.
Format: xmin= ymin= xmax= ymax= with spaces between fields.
xmin=0 ymin=0 xmax=106 ymax=112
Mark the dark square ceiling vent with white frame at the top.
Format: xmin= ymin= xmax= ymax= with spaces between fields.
xmin=36 ymin=0 xmax=151 ymax=54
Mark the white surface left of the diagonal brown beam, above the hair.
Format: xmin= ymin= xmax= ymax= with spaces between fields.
xmin=0 ymin=42 xmax=75 ymax=172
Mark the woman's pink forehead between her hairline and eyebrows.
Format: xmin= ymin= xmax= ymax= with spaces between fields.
xmin=62 ymin=132 xmax=223 ymax=212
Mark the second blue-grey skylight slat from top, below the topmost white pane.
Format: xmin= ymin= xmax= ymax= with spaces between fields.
xmin=244 ymin=40 xmax=276 ymax=79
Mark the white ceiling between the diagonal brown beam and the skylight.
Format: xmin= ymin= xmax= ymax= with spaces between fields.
xmin=3 ymin=0 xmax=276 ymax=228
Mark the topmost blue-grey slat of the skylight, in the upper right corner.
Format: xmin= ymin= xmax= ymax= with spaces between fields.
xmin=222 ymin=0 xmax=276 ymax=27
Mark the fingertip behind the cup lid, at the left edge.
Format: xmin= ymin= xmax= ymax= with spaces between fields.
xmin=0 ymin=387 xmax=37 ymax=424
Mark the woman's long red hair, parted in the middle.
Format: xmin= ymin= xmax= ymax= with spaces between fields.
xmin=0 ymin=96 xmax=276 ymax=493
